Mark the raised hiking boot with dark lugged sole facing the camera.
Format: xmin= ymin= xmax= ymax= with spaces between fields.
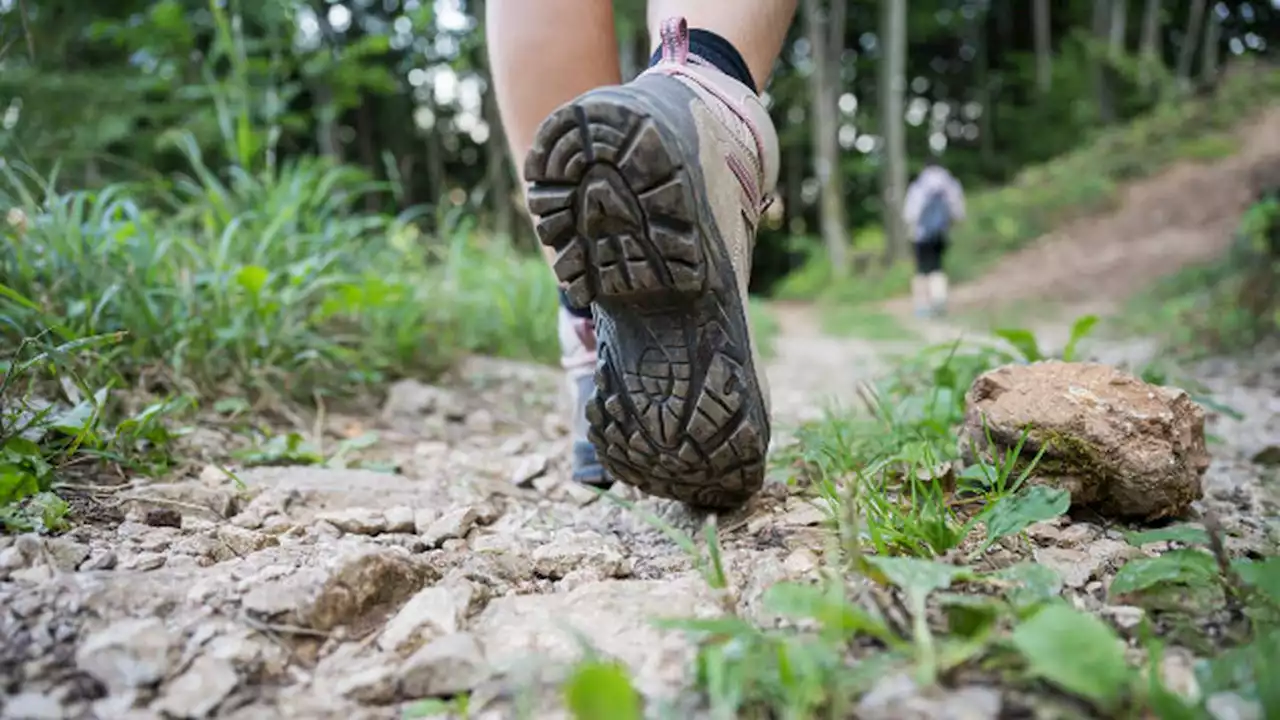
xmin=525 ymin=18 xmax=778 ymax=509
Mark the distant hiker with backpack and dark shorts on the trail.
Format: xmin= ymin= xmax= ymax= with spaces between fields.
xmin=902 ymin=161 xmax=964 ymax=315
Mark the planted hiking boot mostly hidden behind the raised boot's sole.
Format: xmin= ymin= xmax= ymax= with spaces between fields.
xmin=559 ymin=307 xmax=612 ymax=489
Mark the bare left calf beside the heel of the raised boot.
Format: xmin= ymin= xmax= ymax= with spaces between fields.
xmin=485 ymin=0 xmax=622 ymax=266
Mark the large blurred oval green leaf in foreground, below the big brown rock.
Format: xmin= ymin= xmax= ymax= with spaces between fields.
xmin=1012 ymin=603 xmax=1133 ymax=708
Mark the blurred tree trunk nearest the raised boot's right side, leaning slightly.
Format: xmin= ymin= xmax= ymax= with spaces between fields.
xmin=804 ymin=0 xmax=849 ymax=278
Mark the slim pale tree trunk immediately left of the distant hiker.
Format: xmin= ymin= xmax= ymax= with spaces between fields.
xmin=881 ymin=0 xmax=908 ymax=265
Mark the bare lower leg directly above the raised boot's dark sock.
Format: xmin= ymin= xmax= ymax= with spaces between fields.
xmin=648 ymin=0 xmax=796 ymax=88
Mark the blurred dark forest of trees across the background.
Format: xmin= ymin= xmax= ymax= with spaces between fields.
xmin=0 ymin=0 xmax=1280 ymax=290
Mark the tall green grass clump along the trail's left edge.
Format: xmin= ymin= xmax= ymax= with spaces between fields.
xmin=0 ymin=3 xmax=557 ymax=398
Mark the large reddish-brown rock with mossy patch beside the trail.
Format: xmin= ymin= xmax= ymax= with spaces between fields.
xmin=960 ymin=361 xmax=1210 ymax=520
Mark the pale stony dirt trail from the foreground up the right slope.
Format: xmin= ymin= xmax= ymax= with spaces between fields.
xmin=0 ymin=111 xmax=1280 ymax=720
